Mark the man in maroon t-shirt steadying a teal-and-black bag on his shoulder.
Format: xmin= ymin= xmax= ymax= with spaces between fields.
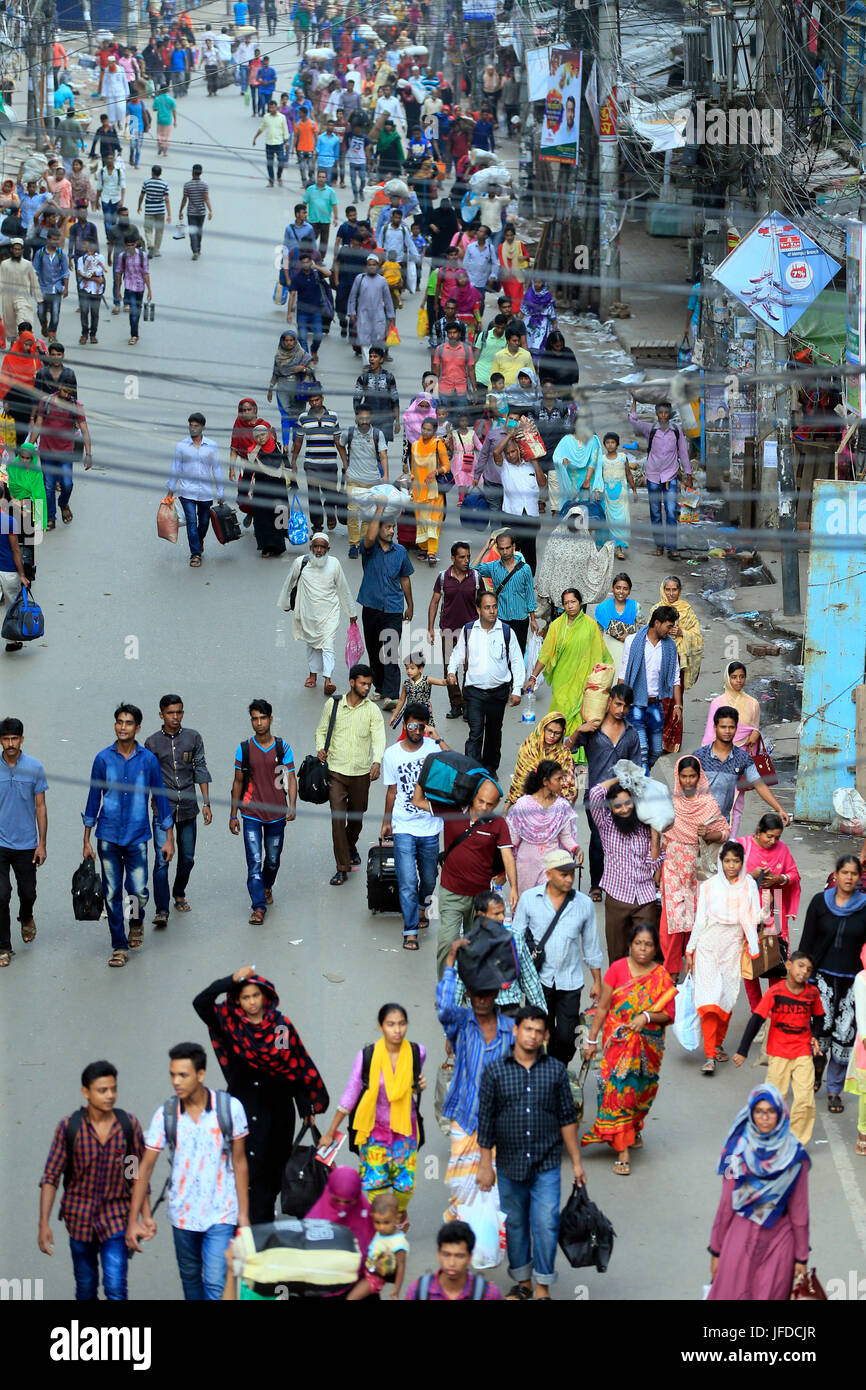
xmin=411 ymin=780 xmax=517 ymax=979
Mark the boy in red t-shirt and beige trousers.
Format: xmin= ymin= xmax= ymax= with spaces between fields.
xmin=734 ymin=951 xmax=824 ymax=1144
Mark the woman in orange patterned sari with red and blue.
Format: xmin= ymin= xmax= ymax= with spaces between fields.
xmin=581 ymin=923 xmax=677 ymax=1177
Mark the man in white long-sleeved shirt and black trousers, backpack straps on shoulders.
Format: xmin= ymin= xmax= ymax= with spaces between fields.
xmin=446 ymin=594 xmax=525 ymax=777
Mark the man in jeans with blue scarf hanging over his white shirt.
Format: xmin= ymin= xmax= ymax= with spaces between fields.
xmin=620 ymin=603 xmax=683 ymax=773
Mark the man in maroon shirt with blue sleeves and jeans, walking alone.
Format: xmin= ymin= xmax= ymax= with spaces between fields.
xmin=228 ymin=699 xmax=297 ymax=927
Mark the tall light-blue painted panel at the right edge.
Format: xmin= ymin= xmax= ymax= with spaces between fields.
xmin=795 ymin=480 xmax=866 ymax=824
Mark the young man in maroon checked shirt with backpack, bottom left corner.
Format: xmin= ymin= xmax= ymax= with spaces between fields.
xmin=39 ymin=1061 xmax=147 ymax=1302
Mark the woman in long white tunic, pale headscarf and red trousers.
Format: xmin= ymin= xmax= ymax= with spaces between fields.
xmin=685 ymin=840 xmax=760 ymax=1076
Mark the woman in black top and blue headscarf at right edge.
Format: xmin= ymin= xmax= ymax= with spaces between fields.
xmin=799 ymin=855 xmax=866 ymax=1115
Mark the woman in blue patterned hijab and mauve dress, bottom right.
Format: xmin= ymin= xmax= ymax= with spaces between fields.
xmin=708 ymin=1086 xmax=812 ymax=1302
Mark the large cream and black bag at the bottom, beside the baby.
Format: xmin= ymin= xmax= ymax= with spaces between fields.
xmin=229 ymin=1217 xmax=360 ymax=1298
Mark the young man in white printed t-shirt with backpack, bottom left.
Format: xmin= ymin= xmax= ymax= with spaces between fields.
xmin=126 ymin=1043 xmax=249 ymax=1302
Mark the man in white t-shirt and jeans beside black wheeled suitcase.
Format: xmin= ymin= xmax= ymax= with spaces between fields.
xmin=382 ymin=703 xmax=448 ymax=951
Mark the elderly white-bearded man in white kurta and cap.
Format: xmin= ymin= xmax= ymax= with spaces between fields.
xmin=278 ymin=531 xmax=357 ymax=695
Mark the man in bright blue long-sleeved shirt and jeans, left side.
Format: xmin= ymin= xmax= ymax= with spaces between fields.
xmin=81 ymin=705 xmax=174 ymax=969
